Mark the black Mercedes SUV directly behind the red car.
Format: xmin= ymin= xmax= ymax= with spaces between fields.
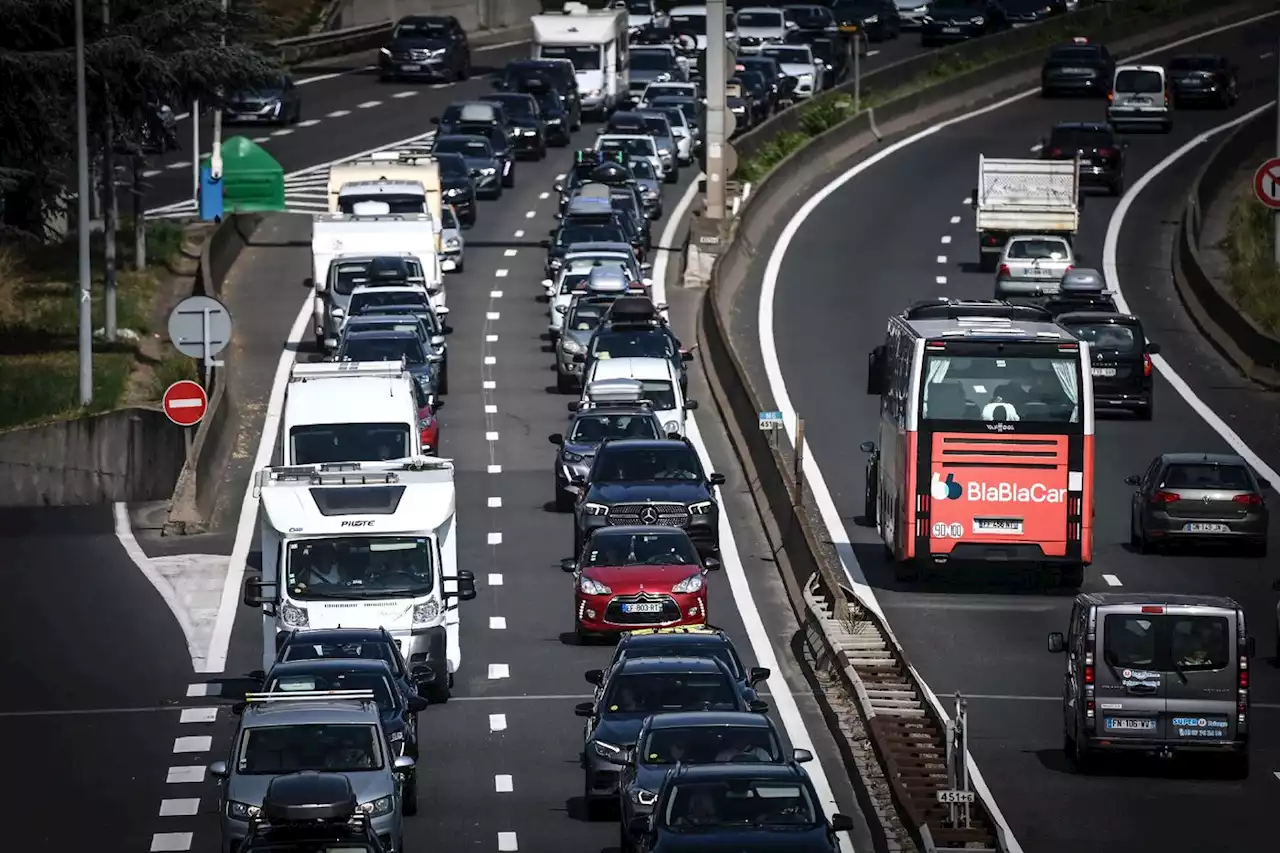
xmin=570 ymin=438 xmax=724 ymax=558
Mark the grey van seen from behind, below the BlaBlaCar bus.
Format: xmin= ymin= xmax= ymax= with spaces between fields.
xmin=1048 ymin=593 xmax=1254 ymax=779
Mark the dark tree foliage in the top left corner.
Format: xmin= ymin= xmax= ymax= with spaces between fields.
xmin=0 ymin=0 xmax=279 ymax=236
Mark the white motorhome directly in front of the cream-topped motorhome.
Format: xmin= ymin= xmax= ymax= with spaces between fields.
xmin=307 ymin=213 xmax=448 ymax=350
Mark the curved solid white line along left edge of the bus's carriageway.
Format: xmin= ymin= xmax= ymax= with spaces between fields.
xmin=758 ymin=12 xmax=1280 ymax=853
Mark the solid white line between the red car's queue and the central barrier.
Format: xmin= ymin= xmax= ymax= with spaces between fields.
xmin=653 ymin=178 xmax=854 ymax=853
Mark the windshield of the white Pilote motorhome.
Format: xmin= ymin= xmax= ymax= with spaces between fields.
xmin=284 ymin=535 xmax=433 ymax=601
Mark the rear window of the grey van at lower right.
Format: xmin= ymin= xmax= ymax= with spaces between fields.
xmin=1102 ymin=613 xmax=1231 ymax=671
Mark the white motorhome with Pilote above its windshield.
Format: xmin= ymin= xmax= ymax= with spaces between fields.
xmin=244 ymin=457 xmax=476 ymax=702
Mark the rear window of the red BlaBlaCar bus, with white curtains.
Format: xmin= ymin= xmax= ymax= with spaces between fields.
xmin=923 ymin=355 xmax=1080 ymax=424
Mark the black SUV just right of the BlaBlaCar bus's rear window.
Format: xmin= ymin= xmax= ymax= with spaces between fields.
xmin=1057 ymin=311 xmax=1160 ymax=420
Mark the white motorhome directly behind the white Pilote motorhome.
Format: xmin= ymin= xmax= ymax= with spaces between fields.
xmin=279 ymin=361 xmax=429 ymax=465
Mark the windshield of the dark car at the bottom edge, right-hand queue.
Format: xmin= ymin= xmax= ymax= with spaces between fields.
xmin=662 ymin=777 xmax=818 ymax=833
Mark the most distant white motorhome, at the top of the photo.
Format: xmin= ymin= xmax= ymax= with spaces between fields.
xmin=530 ymin=3 xmax=631 ymax=118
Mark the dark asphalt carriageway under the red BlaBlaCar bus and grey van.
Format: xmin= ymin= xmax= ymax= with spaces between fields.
xmin=762 ymin=18 xmax=1280 ymax=853
